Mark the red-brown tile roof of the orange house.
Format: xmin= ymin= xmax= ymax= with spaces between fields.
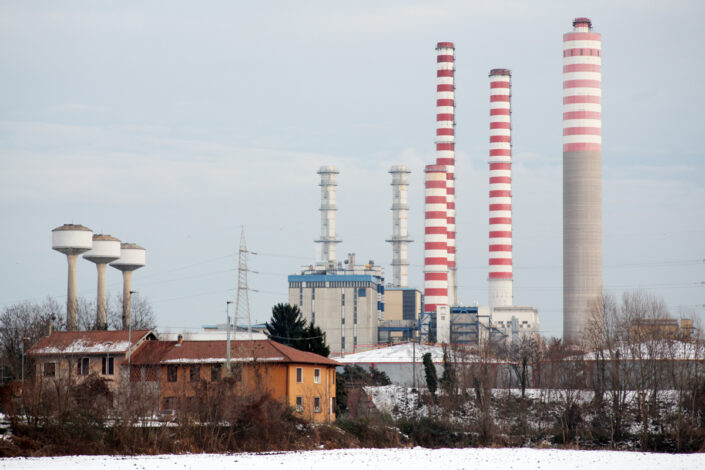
xmin=131 ymin=340 xmax=341 ymax=366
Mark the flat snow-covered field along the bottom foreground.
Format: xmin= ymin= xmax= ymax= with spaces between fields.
xmin=0 ymin=447 xmax=705 ymax=470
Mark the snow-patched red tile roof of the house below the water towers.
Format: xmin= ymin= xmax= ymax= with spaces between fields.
xmin=27 ymin=330 xmax=156 ymax=356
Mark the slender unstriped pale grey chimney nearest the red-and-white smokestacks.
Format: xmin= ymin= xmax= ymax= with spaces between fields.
xmin=387 ymin=165 xmax=412 ymax=287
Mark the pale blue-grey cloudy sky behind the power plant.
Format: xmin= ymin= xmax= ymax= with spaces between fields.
xmin=0 ymin=0 xmax=705 ymax=337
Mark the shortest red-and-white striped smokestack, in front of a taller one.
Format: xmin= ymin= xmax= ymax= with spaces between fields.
xmin=424 ymin=165 xmax=448 ymax=312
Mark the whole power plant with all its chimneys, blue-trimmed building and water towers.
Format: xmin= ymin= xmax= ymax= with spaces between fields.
xmin=52 ymin=18 xmax=602 ymax=354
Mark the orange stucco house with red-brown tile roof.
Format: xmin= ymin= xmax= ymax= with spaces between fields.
xmin=130 ymin=340 xmax=340 ymax=422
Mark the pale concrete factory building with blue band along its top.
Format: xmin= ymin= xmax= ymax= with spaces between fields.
xmin=289 ymin=254 xmax=384 ymax=355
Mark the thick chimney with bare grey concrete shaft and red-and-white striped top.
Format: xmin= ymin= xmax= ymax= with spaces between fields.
xmin=563 ymin=18 xmax=602 ymax=342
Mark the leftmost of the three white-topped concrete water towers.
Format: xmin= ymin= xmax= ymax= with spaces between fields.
xmin=51 ymin=224 xmax=93 ymax=331
